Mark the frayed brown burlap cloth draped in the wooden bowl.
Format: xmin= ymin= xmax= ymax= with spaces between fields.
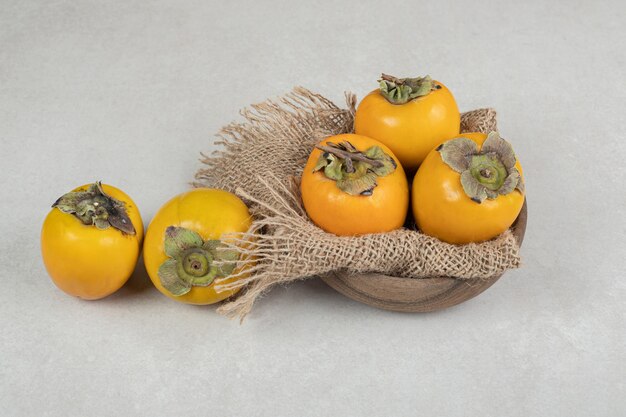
xmin=194 ymin=87 xmax=520 ymax=318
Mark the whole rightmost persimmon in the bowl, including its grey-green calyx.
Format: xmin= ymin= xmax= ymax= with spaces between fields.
xmin=411 ymin=132 xmax=525 ymax=244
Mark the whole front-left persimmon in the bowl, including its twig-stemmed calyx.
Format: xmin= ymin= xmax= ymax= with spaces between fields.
xmin=300 ymin=134 xmax=409 ymax=236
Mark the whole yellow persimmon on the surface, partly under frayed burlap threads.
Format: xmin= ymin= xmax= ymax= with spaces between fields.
xmin=143 ymin=188 xmax=252 ymax=304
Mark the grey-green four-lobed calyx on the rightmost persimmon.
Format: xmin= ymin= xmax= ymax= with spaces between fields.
xmin=437 ymin=132 xmax=524 ymax=203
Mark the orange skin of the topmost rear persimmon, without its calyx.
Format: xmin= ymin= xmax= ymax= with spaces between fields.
xmin=354 ymin=81 xmax=461 ymax=175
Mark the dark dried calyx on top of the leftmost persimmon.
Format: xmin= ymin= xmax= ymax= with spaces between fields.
xmin=52 ymin=181 xmax=136 ymax=235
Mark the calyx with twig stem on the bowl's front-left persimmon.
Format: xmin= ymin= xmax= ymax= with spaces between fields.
xmin=313 ymin=141 xmax=397 ymax=196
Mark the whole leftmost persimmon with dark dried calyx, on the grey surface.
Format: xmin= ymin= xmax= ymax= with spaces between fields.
xmin=41 ymin=182 xmax=143 ymax=300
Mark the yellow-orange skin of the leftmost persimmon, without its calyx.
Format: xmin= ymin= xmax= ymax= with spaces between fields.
xmin=41 ymin=184 xmax=143 ymax=300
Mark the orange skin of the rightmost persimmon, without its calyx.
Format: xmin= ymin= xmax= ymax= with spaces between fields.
xmin=411 ymin=133 xmax=524 ymax=244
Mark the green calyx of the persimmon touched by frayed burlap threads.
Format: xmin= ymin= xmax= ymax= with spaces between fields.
xmin=158 ymin=226 xmax=238 ymax=296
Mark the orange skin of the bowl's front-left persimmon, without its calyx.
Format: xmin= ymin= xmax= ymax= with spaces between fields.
xmin=300 ymin=134 xmax=409 ymax=236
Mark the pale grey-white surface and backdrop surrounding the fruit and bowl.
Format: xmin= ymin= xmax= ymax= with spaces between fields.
xmin=0 ymin=0 xmax=626 ymax=417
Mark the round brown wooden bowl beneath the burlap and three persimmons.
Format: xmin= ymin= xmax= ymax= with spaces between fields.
xmin=321 ymin=201 xmax=528 ymax=313
